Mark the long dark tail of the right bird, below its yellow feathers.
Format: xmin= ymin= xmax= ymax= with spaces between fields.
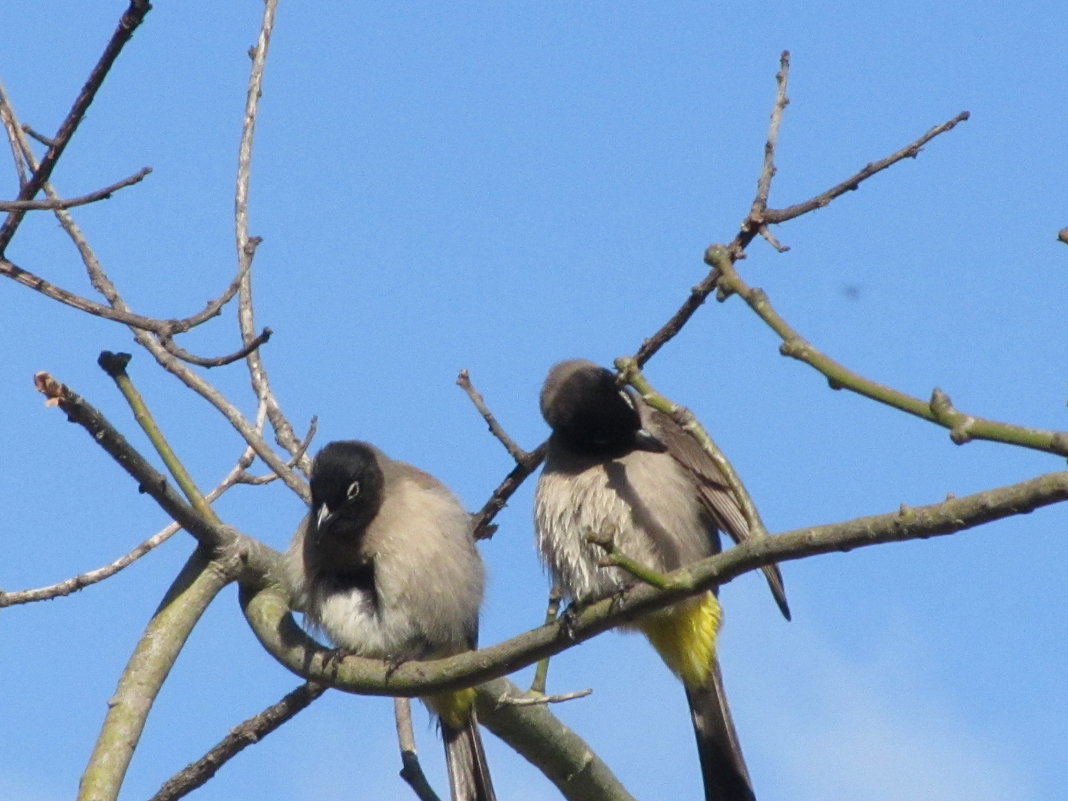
xmin=686 ymin=660 xmax=756 ymax=801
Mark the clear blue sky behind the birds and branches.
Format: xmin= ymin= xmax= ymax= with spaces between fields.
xmin=0 ymin=0 xmax=1068 ymax=801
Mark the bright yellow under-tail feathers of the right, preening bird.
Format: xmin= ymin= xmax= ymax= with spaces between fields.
xmin=633 ymin=593 xmax=723 ymax=687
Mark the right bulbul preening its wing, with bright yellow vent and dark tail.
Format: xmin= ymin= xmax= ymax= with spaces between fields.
xmin=534 ymin=359 xmax=789 ymax=801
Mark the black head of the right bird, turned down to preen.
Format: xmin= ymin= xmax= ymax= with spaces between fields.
xmin=540 ymin=359 xmax=668 ymax=458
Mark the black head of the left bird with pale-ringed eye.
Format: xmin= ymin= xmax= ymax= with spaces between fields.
xmin=310 ymin=441 xmax=384 ymax=539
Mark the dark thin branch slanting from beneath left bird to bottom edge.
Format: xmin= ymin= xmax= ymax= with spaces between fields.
xmin=150 ymin=681 xmax=327 ymax=801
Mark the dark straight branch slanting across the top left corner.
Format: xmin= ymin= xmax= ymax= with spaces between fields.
xmin=0 ymin=0 xmax=152 ymax=254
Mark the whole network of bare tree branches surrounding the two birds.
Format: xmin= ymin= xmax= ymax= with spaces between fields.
xmin=0 ymin=7 xmax=1068 ymax=801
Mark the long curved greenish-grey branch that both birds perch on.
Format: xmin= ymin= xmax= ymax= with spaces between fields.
xmin=240 ymin=471 xmax=1068 ymax=696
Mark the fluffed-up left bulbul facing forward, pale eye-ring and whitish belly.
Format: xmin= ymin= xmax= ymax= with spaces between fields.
xmin=286 ymin=441 xmax=494 ymax=801
